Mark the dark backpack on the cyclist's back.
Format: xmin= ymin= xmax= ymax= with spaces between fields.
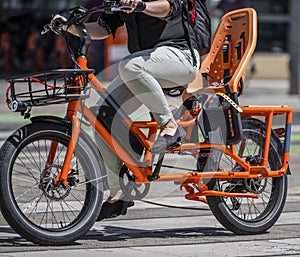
xmin=182 ymin=0 xmax=211 ymax=55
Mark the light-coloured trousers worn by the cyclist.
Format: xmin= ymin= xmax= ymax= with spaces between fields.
xmin=97 ymin=46 xmax=200 ymax=187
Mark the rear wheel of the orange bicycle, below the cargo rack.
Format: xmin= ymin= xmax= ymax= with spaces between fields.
xmin=207 ymin=118 xmax=288 ymax=234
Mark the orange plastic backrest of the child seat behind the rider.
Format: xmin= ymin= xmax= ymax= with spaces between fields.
xmin=187 ymin=8 xmax=257 ymax=93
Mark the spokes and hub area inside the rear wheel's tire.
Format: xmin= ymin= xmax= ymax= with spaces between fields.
xmin=211 ymin=119 xmax=286 ymax=221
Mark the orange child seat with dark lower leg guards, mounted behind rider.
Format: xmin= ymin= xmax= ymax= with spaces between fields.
xmin=183 ymin=8 xmax=257 ymax=145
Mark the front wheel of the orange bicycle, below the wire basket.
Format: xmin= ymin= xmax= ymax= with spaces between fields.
xmin=0 ymin=122 xmax=104 ymax=245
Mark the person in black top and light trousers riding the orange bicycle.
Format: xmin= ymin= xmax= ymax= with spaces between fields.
xmin=53 ymin=0 xmax=200 ymax=220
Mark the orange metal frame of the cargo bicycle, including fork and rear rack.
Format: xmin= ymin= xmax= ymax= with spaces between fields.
xmin=51 ymin=54 xmax=292 ymax=201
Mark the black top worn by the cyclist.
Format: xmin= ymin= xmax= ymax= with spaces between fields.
xmin=98 ymin=0 xmax=196 ymax=53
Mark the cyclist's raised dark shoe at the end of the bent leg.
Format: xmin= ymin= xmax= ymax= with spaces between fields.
xmin=151 ymin=126 xmax=186 ymax=154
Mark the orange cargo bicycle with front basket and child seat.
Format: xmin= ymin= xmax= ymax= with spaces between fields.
xmin=0 ymin=4 xmax=292 ymax=245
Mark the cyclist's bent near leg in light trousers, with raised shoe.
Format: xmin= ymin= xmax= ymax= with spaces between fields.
xmin=119 ymin=46 xmax=199 ymax=153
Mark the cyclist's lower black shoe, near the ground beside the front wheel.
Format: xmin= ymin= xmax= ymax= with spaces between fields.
xmin=96 ymin=200 xmax=134 ymax=221
